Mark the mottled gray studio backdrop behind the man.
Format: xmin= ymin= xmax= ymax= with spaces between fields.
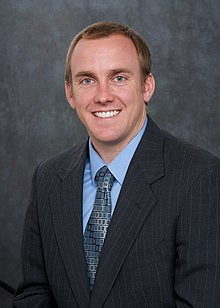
xmin=0 ymin=0 xmax=220 ymax=307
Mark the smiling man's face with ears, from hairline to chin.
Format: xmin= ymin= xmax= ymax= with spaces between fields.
xmin=66 ymin=35 xmax=154 ymax=152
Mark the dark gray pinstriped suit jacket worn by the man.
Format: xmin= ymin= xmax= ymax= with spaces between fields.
xmin=14 ymin=119 xmax=220 ymax=308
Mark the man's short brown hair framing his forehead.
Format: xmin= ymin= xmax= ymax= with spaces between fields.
xmin=65 ymin=21 xmax=152 ymax=84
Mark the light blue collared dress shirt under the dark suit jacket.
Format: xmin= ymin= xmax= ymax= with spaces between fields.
xmin=83 ymin=117 xmax=147 ymax=233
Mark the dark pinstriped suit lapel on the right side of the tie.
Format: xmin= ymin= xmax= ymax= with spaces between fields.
xmin=90 ymin=119 xmax=164 ymax=308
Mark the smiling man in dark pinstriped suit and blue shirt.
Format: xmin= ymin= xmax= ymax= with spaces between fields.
xmin=14 ymin=22 xmax=220 ymax=308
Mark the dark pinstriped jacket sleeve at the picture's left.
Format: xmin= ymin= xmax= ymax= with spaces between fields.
xmin=13 ymin=167 xmax=57 ymax=308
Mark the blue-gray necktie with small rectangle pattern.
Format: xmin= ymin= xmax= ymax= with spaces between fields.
xmin=84 ymin=166 xmax=115 ymax=290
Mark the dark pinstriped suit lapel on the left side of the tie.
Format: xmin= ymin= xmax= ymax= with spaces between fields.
xmin=50 ymin=143 xmax=90 ymax=307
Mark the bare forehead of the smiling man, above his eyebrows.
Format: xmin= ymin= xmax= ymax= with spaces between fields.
xmin=71 ymin=34 xmax=139 ymax=68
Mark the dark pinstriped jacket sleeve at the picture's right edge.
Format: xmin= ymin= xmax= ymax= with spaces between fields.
xmin=174 ymin=164 xmax=220 ymax=308
